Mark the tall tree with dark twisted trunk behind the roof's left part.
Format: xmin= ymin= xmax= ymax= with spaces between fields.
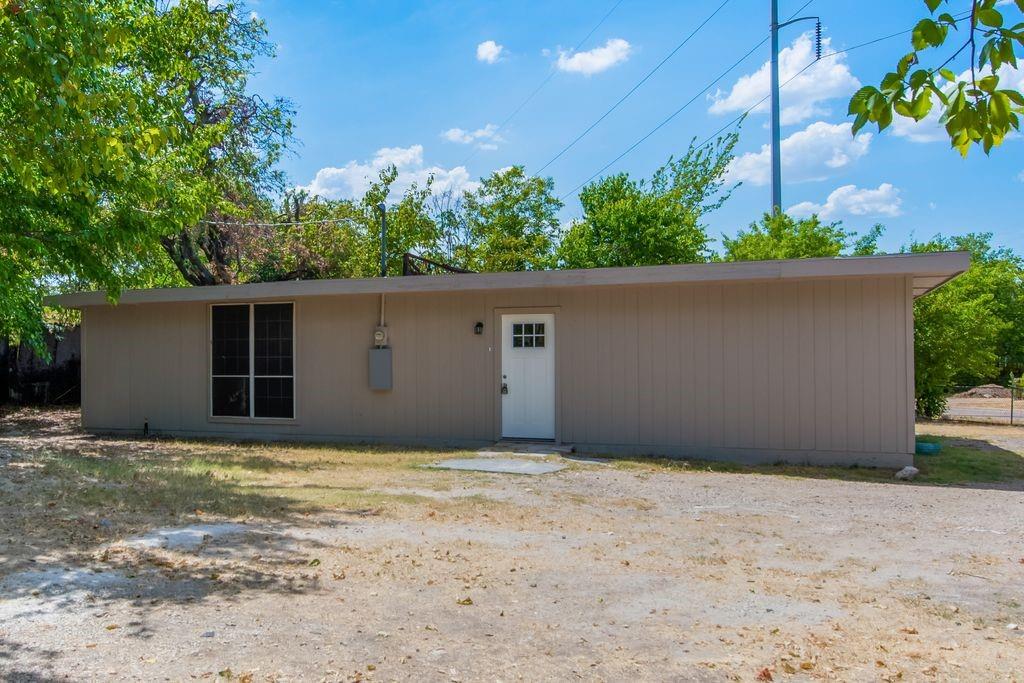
xmin=149 ymin=0 xmax=294 ymax=285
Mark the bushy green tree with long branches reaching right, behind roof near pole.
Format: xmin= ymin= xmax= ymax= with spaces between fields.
xmin=558 ymin=134 xmax=737 ymax=268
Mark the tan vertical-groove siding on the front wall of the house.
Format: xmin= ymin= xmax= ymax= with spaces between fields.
xmin=77 ymin=276 xmax=913 ymax=465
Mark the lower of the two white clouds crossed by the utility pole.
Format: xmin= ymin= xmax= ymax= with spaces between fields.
xmin=726 ymin=121 xmax=871 ymax=185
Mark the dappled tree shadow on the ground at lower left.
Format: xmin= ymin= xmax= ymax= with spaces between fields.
xmin=0 ymin=405 xmax=344 ymax=606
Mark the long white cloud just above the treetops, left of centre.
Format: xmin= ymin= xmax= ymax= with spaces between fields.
xmin=302 ymin=144 xmax=479 ymax=200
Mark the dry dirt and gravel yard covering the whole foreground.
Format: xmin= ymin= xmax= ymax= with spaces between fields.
xmin=0 ymin=412 xmax=1024 ymax=681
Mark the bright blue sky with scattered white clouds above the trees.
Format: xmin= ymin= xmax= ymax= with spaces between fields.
xmin=248 ymin=0 xmax=1024 ymax=251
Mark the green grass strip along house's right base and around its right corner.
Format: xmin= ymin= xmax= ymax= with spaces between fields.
xmin=602 ymin=436 xmax=1024 ymax=485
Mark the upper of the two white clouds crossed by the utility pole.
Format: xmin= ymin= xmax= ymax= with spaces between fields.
xmin=710 ymin=33 xmax=860 ymax=125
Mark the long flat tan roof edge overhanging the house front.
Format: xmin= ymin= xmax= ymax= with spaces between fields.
xmin=45 ymin=252 xmax=971 ymax=308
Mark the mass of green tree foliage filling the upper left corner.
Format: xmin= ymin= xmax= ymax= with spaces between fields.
xmin=0 ymin=0 xmax=291 ymax=340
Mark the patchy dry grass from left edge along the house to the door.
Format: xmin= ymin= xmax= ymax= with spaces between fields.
xmin=0 ymin=411 xmax=499 ymax=574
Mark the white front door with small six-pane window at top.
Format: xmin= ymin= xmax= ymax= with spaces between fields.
xmin=501 ymin=313 xmax=555 ymax=438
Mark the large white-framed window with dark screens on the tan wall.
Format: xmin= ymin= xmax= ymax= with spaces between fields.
xmin=210 ymin=303 xmax=295 ymax=418
